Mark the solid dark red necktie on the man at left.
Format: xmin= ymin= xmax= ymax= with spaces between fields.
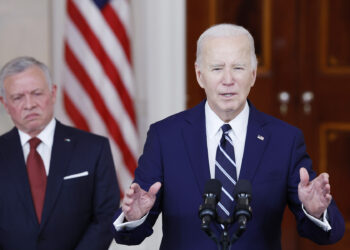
xmin=27 ymin=137 xmax=47 ymax=223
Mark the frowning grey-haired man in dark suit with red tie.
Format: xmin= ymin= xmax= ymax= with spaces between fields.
xmin=0 ymin=57 xmax=119 ymax=250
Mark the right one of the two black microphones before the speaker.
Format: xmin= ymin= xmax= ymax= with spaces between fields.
xmin=234 ymin=179 xmax=252 ymax=230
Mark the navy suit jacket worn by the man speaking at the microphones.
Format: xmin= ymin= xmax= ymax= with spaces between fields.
xmin=114 ymin=101 xmax=344 ymax=250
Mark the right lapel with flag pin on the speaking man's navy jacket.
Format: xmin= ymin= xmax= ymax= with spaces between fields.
xmin=239 ymin=103 xmax=270 ymax=182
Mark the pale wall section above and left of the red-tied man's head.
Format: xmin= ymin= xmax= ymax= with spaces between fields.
xmin=0 ymin=0 xmax=51 ymax=134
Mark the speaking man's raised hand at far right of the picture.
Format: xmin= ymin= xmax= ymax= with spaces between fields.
xmin=298 ymin=168 xmax=332 ymax=218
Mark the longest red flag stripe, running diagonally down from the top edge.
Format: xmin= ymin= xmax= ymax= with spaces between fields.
xmin=67 ymin=0 xmax=136 ymax=127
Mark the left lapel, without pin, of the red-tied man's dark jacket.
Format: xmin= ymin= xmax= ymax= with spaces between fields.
xmin=2 ymin=128 xmax=38 ymax=223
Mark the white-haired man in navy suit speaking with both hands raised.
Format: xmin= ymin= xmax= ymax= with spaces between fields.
xmin=113 ymin=24 xmax=344 ymax=250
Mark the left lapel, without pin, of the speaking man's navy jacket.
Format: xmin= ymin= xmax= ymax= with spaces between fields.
xmin=182 ymin=101 xmax=210 ymax=194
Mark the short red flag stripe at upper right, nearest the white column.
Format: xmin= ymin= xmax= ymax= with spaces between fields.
xmin=102 ymin=4 xmax=132 ymax=65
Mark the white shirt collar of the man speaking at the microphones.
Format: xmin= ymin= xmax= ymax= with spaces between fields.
xmin=205 ymin=101 xmax=249 ymax=140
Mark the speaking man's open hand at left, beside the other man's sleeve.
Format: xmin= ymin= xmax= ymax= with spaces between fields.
xmin=122 ymin=182 xmax=162 ymax=221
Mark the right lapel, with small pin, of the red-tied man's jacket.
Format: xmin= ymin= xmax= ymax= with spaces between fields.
xmin=40 ymin=121 xmax=75 ymax=228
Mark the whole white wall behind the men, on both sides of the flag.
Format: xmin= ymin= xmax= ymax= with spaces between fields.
xmin=0 ymin=0 xmax=185 ymax=250
